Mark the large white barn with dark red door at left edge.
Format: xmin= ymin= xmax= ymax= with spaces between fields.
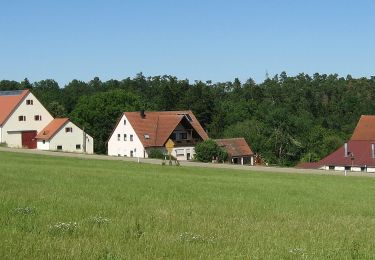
xmin=0 ymin=90 xmax=53 ymax=149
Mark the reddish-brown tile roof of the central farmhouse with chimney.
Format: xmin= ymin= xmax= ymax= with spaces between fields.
xmin=124 ymin=110 xmax=208 ymax=147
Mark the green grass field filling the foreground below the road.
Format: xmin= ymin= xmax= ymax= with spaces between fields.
xmin=0 ymin=152 xmax=375 ymax=259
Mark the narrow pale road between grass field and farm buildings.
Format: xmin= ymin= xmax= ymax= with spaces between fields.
xmin=0 ymin=147 xmax=375 ymax=177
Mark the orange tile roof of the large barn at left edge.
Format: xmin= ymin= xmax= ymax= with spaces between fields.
xmin=0 ymin=89 xmax=30 ymax=125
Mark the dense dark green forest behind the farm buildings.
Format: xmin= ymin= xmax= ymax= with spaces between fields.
xmin=0 ymin=72 xmax=375 ymax=165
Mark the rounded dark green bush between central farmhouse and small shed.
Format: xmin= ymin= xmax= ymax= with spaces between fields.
xmin=195 ymin=139 xmax=228 ymax=162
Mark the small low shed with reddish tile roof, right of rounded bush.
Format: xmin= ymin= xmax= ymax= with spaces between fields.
xmin=215 ymin=138 xmax=254 ymax=165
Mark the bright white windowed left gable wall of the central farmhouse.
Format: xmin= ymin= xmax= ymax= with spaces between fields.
xmin=108 ymin=115 xmax=148 ymax=158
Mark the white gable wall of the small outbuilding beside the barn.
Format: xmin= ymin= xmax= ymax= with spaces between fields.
xmin=47 ymin=121 xmax=94 ymax=154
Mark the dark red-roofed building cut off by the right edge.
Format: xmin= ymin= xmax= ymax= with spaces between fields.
xmin=297 ymin=115 xmax=375 ymax=172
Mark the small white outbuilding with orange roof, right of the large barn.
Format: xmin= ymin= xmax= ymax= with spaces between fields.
xmin=35 ymin=118 xmax=94 ymax=154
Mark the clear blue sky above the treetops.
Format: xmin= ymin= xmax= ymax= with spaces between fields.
xmin=0 ymin=0 xmax=375 ymax=86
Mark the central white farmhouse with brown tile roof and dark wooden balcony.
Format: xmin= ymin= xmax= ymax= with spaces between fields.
xmin=108 ymin=111 xmax=208 ymax=160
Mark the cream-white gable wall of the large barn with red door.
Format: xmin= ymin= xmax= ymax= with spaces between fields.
xmin=2 ymin=93 xmax=53 ymax=147
